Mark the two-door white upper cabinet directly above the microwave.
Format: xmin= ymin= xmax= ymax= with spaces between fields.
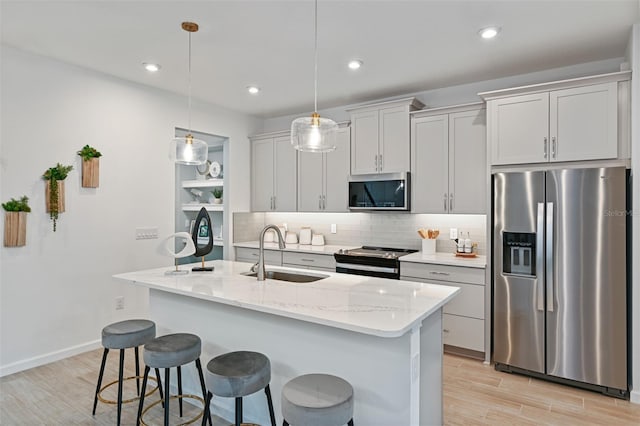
xmin=349 ymin=98 xmax=423 ymax=175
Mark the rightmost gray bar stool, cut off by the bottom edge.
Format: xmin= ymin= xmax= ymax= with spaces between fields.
xmin=282 ymin=374 xmax=353 ymax=426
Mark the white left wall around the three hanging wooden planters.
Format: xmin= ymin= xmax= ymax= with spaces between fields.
xmin=0 ymin=46 xmax=262 ymax=375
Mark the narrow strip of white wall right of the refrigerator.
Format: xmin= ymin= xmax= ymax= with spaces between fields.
xmin=628 ymin=23 xmax=640 ymax=404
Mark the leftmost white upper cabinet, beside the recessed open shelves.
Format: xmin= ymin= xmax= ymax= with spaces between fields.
xmin=251 ymin=134 xmax=297 ymax=212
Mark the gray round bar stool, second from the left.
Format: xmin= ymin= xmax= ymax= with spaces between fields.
xmin=136 ymin=333 xmax=211 ymax=426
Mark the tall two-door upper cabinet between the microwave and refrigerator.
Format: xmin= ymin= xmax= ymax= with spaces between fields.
xmin=411 ymin=104 xmax=487 ymax=214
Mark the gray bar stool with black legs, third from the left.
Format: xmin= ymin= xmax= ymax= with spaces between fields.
xmin=202 ymin=351 xmax=276 ymax=426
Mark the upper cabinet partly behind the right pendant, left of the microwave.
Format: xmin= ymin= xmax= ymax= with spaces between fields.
xmin=298 ymin=127 xmax=351 ymax=212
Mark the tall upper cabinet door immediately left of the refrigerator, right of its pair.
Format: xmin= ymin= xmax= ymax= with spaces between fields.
xmin=449 ymin=109 xmax=488 ymax=214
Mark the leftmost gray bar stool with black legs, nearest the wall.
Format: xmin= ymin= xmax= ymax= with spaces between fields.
xmin=92 ymin=319 xmax=162 ymax=425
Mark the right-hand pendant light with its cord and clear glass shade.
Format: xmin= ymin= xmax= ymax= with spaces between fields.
xmin=291 ymin=0 xmax=338 ymax=152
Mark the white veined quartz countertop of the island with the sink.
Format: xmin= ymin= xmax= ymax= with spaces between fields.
xmin=114 ymin=260 xmax=460 ymax=337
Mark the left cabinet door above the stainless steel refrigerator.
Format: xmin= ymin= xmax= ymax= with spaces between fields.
xmin=487 ymin=93 xmax=549 ymax=164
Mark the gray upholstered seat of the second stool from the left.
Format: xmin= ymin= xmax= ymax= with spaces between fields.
xmin=144 ymin=333 xmax=202 ymax=368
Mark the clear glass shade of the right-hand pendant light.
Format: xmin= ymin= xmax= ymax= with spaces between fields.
xmin=291 ymin=112 xmax=338 ymax=152
